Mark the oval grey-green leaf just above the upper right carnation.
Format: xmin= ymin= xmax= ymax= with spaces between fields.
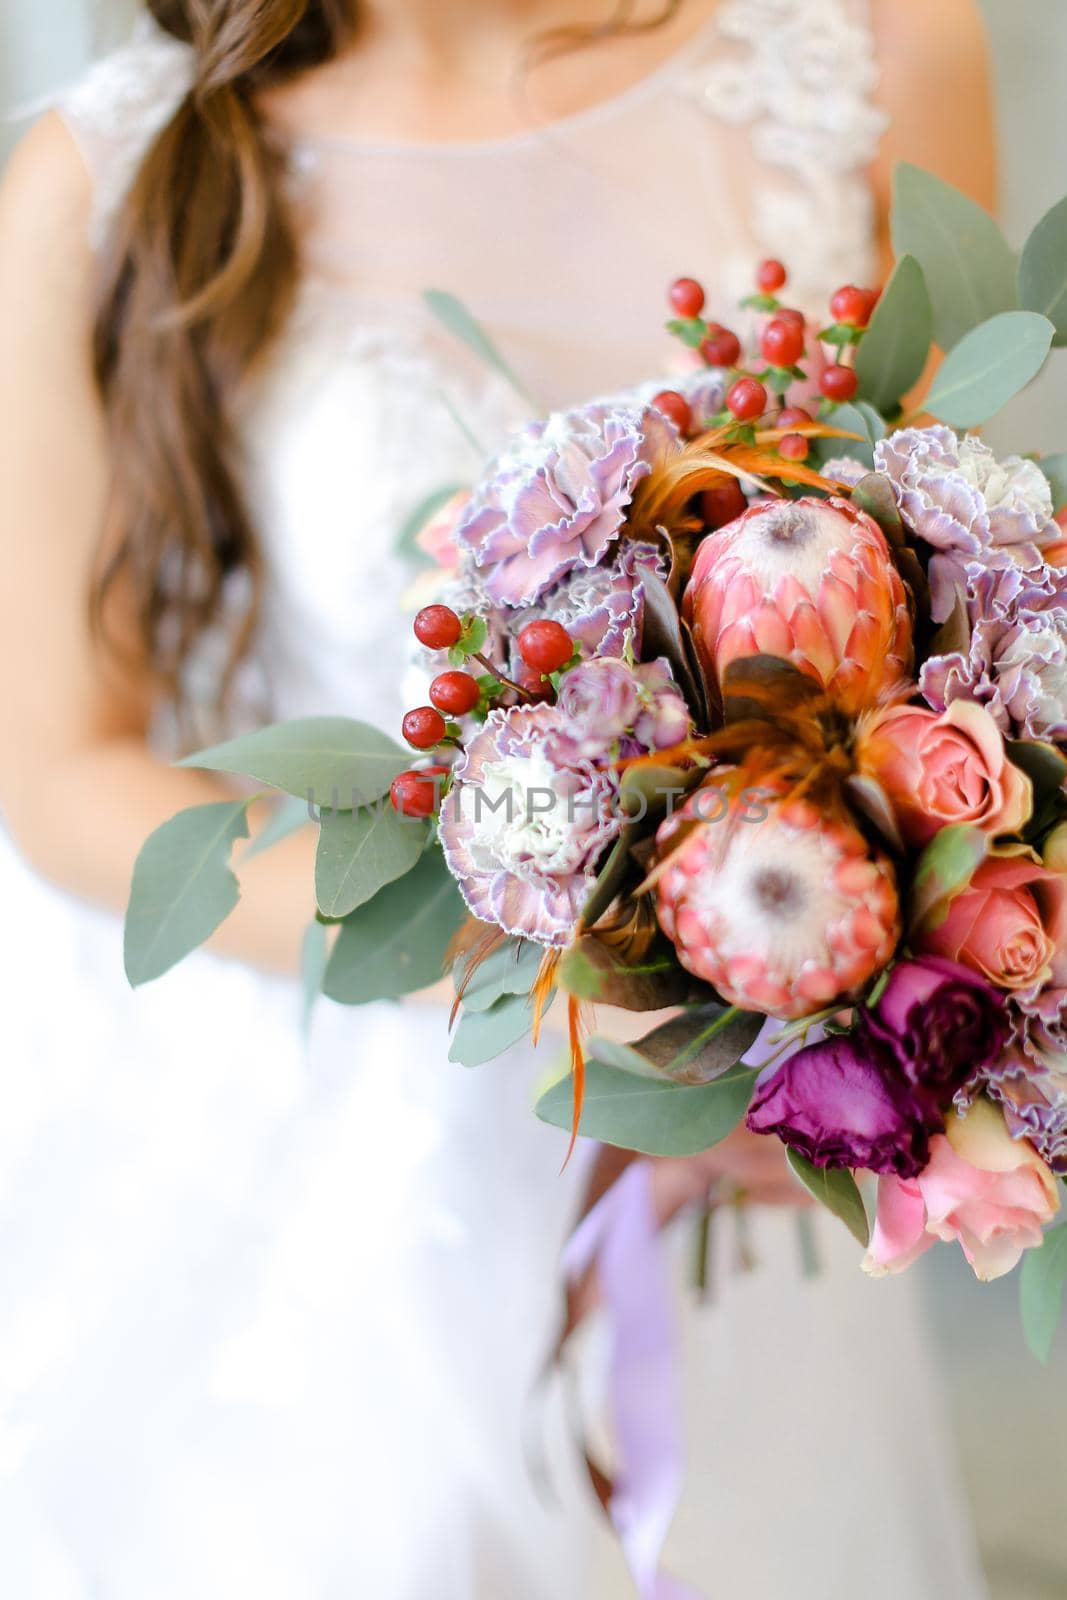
xmin=923 ymin=310 xmax=1054 ymax=427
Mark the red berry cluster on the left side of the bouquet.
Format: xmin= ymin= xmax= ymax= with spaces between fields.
xmin=389 ymin=605 xmax=574 ymax=818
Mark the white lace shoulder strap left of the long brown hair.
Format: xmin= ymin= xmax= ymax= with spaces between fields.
xmin=54 ymin=21 xmax=192 ymax=243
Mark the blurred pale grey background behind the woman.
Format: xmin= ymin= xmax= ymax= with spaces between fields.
xmin=0 ymin=0 xmax=1067 ymax=1600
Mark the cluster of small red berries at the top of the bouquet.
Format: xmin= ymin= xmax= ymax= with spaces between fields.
xmin=653 ymin=259 xmax=880 ymax=467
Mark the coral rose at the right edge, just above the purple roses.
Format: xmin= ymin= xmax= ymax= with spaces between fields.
xmin=913 ymin=845 xmax=1067 ymax=992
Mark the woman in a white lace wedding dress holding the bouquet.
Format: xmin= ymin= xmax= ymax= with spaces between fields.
xmin=0 ymin=0 xmax=992 ymax=1600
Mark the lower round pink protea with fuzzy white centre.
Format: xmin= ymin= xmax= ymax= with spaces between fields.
xmin=657 ymin=771 xmax=899 ymax=1018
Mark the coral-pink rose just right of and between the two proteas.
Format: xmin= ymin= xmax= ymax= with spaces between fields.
xmin=859 ymin=699 xmax=1033 ymax=845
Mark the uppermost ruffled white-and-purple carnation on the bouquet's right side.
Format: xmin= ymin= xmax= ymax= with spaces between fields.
xmin=875 ymin=426 xmax=1061 ymax=622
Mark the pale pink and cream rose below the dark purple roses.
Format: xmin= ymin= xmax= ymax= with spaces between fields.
xmin=864 ymin=1099 xmax=1059 ymax=1282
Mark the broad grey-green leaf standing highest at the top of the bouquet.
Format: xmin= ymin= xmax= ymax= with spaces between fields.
xmin=891 ymin=162 xmax=1017 ymax=350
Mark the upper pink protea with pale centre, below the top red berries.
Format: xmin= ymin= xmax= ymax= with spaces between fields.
xmin=683 ymin=498 xmax=912 ymax=709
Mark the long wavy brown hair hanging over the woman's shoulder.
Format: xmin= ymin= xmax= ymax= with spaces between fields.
xmin=91 ymin=0 xmax=681 ymax=698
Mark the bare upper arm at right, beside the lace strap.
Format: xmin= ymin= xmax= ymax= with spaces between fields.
xmin=873 ymin=0 xmax=997 ymax=272
